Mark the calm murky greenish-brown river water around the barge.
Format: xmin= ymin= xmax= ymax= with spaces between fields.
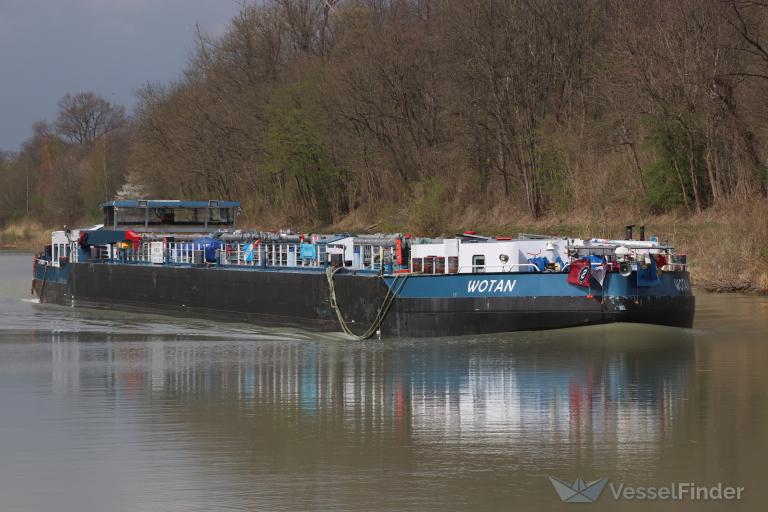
xmin=0 ymin=253 xmax=768 ymax=512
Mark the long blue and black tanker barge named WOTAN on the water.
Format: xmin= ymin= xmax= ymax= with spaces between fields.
xmin=32 ymin=200 xmax=695 ymax=339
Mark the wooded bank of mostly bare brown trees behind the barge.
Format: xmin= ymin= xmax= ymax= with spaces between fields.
xmin=0 ymin=0 xmax=768 ymax=293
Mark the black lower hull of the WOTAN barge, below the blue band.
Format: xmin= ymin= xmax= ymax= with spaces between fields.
xmin=34 ymin=263 xmax=694 ymax=337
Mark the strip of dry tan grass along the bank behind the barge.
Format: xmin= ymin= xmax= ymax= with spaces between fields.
xmin=0 ymin=202 xmax=768 ymax=295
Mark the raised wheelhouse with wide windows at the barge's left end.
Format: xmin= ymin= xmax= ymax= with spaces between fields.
xmin=101 ymin=199 xmax=240 ymax=233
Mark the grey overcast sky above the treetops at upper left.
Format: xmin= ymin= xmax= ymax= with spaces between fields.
xmin=0 ymin=0 xmax=239 ymax=151
